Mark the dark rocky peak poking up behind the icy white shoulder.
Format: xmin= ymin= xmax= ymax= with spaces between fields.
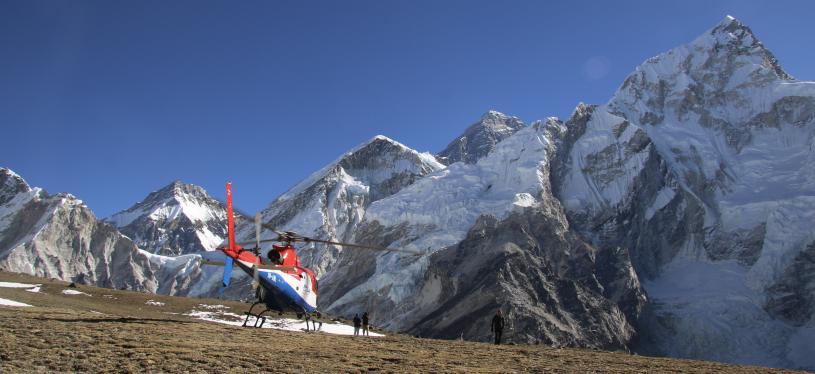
xmin=437 ymin=110 xmax=524 ymax=165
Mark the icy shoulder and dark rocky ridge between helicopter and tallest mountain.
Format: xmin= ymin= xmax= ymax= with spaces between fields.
xmin=294 ymin=119 xmax=645 ymax=349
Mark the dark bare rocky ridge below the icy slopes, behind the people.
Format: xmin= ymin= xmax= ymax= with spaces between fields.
xmin=396 ymin=208 xmax=645 ymax=349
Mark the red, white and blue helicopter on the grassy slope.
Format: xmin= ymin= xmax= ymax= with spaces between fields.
xmin=202 ymin=182 xmax=422 ymax=328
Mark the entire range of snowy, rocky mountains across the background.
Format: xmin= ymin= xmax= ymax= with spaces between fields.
xmin=0 ymin=17 xmax=815 ymax=369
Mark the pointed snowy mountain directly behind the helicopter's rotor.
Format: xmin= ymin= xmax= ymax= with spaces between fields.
xmin=238 ymin=135 xmax=444 ymax=276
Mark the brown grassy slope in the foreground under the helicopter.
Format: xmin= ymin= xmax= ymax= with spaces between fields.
xmin=0 ymin=272 xmax=804 ymax=373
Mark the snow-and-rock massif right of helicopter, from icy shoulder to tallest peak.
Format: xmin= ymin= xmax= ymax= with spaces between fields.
xmin=244 ymin=17 xmax=815 ymax=368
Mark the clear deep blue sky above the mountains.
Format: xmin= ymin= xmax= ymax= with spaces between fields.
xmin=0 ymin=0 xmax=815 ymax=217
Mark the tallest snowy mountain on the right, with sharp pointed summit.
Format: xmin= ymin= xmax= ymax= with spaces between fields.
xmin=553 ymin=17 xmax=815 ymax=369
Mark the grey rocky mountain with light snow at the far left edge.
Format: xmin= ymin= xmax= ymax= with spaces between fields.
xmin=0 ymin=168 xmax=230 ymax=296
